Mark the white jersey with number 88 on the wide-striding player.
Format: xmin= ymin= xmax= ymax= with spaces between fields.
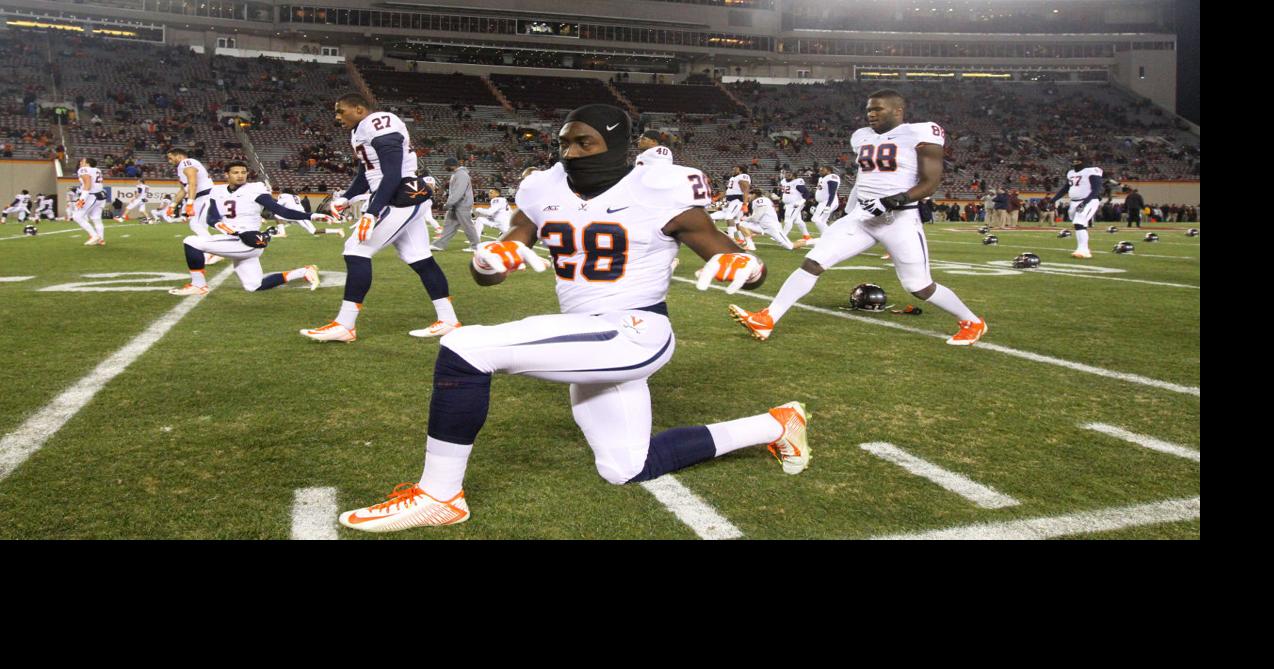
xmin=850 ymin=122 xmax=947 ymax=198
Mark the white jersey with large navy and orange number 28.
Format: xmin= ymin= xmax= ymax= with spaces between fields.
xmin=517 ymin=163 xmax=711 ymax=313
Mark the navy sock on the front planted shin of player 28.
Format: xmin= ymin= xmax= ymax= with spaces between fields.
xmin=429 ymin=347 xmax=489 ymax=443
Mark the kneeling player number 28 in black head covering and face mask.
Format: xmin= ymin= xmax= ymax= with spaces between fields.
xmin=340 ymin=104 xmax=809 ymax=531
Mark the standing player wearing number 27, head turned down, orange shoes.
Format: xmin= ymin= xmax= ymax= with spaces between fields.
xmin=301 ymin=93 xmax=460 ymax=342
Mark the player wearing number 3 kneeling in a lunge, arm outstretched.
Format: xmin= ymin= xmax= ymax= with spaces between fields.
xmin=168 ymin=162 xmax=331 ymax=296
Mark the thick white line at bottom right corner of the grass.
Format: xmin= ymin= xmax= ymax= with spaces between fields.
xmin=873 ymin=497 xmax=1199 ymax=540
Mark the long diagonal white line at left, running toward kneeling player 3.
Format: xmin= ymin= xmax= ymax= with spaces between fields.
xmin=0 ymin=268 xmax=234 ymax=480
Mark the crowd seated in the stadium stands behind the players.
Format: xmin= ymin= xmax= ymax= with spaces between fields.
xmin=0 ymin=34 xmax=1200 ymax=208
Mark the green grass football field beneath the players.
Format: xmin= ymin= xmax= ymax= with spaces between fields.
xmin=0 ymin=216 xmax=1200 ymax=539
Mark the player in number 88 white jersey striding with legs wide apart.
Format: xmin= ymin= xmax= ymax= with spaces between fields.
xmin=730 ymin=89 xmax=986 ymax=347
